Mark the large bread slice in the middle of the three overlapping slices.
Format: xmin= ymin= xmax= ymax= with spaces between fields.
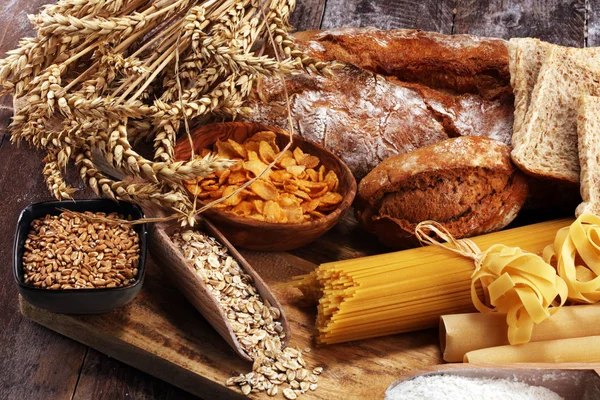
xmin=511 ymin=46 xmax=600 ymax=183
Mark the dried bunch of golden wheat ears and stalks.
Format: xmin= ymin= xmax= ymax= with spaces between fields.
xmin=0 ymin=0 xmax=326 ymax=224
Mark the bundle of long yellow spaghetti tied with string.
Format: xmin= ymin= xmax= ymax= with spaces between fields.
xmin=297 ymin=220 xmax=572 ymax=344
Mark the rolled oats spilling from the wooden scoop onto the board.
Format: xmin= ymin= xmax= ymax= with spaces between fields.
xmin=171 ymin=230 xmax=323 ymax=399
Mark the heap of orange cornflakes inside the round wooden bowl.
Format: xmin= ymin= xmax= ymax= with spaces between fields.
xmin=184 ymin=131 xmax=342 ymax=223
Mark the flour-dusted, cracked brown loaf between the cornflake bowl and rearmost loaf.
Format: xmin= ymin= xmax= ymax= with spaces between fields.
xmin=250 ymin=65 xmax=512 ymax=179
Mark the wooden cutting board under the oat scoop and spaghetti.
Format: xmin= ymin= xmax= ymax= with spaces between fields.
xmin=21 ymin=244 xmax=442 ymax=400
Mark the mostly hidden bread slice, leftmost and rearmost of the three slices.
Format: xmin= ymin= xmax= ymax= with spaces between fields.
xmin=508 ymin=38 xmax=551 ymax=142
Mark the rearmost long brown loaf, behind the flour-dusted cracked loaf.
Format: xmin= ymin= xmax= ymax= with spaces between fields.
xmin=294 ymin=28 xmax=512 ymax=100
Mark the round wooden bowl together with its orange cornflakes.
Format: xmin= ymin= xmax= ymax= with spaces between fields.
xmin=175 ymin=122 xmax=356 ymax=251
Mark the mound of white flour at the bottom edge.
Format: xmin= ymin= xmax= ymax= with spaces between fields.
xmin=385 ymin=375 xmax=563 ymax=400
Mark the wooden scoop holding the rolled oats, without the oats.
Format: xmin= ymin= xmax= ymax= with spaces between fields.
xmin=148 ymin=218 xmax=290 ymax=362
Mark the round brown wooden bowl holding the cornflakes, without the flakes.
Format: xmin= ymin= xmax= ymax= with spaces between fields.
xmin=175 ymin=122 xmax=356 ymax=251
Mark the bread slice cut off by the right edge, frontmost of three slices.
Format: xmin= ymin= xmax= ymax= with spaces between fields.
xmin=575 ymin=96 xmax=600 ymax=217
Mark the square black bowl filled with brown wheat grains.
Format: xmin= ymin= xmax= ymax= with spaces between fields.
xmin=13 ymin=199 xmax=147 ymax=314
